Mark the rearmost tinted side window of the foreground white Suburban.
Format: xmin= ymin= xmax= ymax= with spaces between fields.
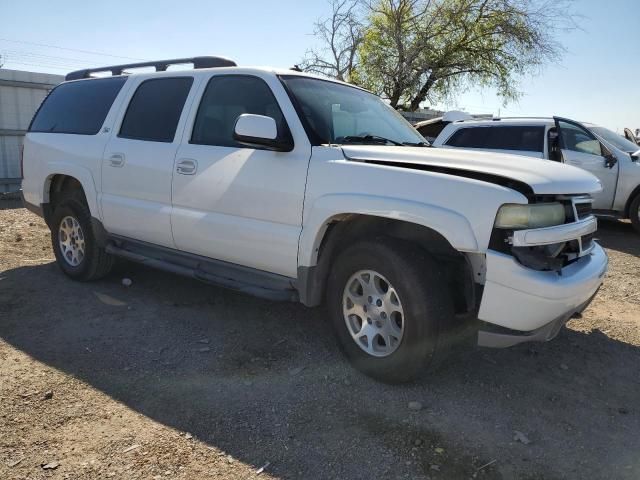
xmin=29 ymin=77 xmax=127 ymax=135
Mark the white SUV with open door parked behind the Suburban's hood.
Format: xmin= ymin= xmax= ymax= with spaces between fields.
xmin=433 ymin=117 xmax=640 ymax=231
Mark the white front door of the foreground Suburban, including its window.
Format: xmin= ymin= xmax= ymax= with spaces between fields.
xmin=171 ymin=74 xmax=311 ymax=277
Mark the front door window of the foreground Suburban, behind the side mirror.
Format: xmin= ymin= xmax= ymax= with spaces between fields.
xmin=190 ymin=75 xmax=291 ymax=148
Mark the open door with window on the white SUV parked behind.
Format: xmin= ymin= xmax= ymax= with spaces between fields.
xmin=554 ymin=117 xmax=619 ymax=210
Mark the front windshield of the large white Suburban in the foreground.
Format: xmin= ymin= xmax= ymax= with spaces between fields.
xmin=281 ymin=76 xmax=426 ymax=145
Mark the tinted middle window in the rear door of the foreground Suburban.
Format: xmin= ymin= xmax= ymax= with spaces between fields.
xmin=118 ymin=77 xmax=193 ymax=143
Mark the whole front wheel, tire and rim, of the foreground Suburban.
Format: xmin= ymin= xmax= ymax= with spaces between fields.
xmin=327 ymin=238 xmax=453 ymax=383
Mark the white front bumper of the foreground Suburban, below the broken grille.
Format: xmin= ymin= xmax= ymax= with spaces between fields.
xmin=478 ymin=244 xmax=608 ymax=346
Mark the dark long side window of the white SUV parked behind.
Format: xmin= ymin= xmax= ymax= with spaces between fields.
xmin=446 ymin=126 xmax=544 ymax=153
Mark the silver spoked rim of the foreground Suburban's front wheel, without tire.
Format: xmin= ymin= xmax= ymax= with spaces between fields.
xmin=342 ymin=270 xmax=405 ymax=357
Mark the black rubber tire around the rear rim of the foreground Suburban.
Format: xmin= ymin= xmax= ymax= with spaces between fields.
xmin=50 ymin=190 xmax=114 ymax=281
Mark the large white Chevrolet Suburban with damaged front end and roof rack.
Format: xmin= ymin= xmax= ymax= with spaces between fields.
xmin=23 ymin=57 xmax=607 ymax=382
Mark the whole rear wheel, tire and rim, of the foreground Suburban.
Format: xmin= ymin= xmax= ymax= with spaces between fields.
xmin=51 ymin=190 xmax=113 ymax=280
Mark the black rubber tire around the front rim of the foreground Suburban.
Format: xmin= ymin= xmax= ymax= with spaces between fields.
xmin=327 ymin=237 xmax=454 ymax=383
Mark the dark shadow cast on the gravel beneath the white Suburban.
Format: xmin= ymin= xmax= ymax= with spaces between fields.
xmin=0 ymin=263 xmax=640 ymax=479
